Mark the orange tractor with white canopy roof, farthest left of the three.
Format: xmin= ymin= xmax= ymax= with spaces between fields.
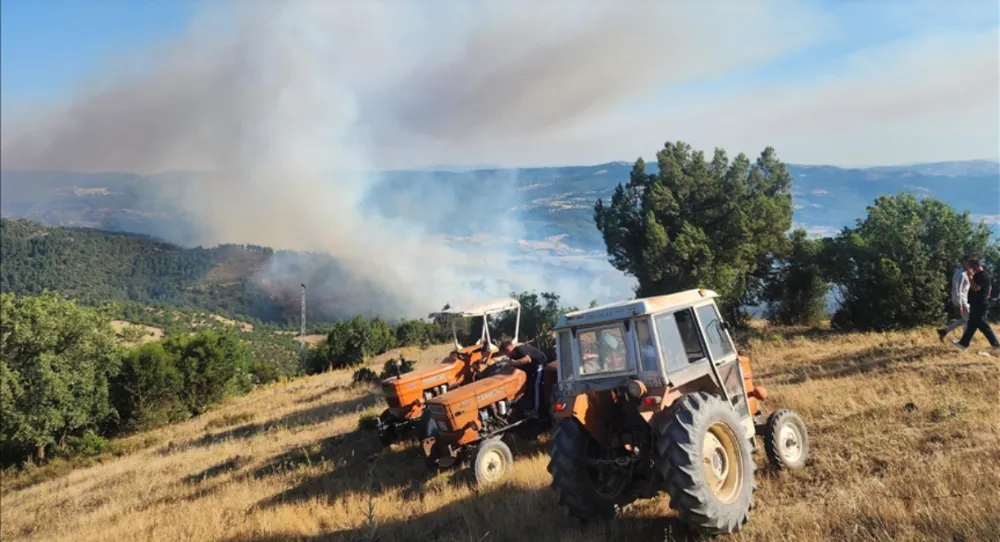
xmin=376 ymin=298 xmax=521 ymax=446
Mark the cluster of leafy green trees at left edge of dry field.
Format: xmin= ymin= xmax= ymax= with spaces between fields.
xmin=0 ymin=292 xmax=276 ymax=464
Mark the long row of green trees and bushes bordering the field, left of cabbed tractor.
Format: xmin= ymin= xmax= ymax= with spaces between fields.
xmin=0 ymin=291 xmax=562 ymax=472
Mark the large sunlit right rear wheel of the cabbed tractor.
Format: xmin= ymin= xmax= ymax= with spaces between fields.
xmin=656 ymin=392 xmax=756 ymax=535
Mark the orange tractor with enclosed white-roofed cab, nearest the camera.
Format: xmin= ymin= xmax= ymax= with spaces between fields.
xmin=548 ymin=290 xmax=809 ymax=535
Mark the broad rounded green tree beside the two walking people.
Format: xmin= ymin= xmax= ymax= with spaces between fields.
xmin=824 ymin=193 xmax=990 ymax=330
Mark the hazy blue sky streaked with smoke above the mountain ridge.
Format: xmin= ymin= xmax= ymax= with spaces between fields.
xmin=0 ymin=0 xmax=1000 ymax=171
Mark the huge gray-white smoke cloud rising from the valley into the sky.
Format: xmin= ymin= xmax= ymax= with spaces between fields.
xmin=2 ymin=0 xmax=820 ymax=316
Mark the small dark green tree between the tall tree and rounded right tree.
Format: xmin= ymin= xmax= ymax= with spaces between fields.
xmin=763 ymin=228 xmax=830 ymax=325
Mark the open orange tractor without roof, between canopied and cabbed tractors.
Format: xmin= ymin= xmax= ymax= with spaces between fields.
xmin=422 ymin=361 xmax=557 ymax=486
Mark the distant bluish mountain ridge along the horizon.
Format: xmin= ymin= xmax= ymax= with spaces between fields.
xmin=0 ymin=160 xmax=1000 ymax=252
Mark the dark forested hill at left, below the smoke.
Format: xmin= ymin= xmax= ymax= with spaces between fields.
xmin=0 ymin=219 xmax=298 ymax=323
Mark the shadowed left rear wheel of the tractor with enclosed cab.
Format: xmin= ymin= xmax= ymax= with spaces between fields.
xmin=548 ymin=418 xmax=637 ymax=523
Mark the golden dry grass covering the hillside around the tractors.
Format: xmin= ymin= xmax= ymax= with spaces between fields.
xmin=2 ymin=330 xmax=1000 ymax=542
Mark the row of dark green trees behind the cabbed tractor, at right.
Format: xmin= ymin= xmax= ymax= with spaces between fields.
xmin=594 ymin=142 xmax=1000 ymax=330
